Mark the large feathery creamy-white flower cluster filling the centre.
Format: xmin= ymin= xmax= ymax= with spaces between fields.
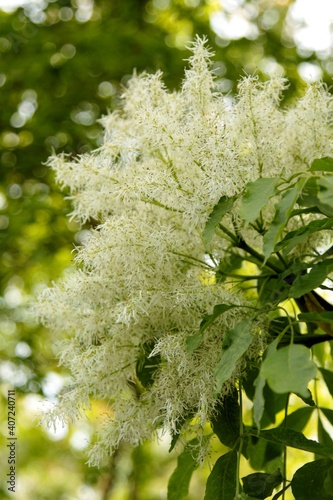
xmin=36 ymin=39 xmax=333 ymax=460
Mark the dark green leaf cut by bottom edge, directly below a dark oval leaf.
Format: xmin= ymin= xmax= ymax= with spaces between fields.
xmin=204 ymin=450 xmax=237 ymax=500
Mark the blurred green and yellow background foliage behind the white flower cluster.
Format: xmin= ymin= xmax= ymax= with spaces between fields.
xmin=0 ymin=0 xmax=333 ymax=500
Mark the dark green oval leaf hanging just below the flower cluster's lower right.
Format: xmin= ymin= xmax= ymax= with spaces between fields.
xmin=211 ymin=389 xmax=240 ymax=448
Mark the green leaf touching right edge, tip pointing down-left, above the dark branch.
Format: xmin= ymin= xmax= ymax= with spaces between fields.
xmin=289 ymin=259 xmax=333 ymax=299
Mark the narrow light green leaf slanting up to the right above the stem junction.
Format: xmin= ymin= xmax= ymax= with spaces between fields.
xmin=263 ymin=178 xmax=306 ymax=260
